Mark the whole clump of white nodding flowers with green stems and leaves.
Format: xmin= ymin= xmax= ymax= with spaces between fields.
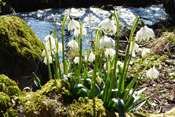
xmin=40 ymin=11 xmax=164 ymax=116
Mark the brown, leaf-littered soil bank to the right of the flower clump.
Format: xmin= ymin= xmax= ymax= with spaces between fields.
xmin=120 ymin=21 xmax=175 ymax=113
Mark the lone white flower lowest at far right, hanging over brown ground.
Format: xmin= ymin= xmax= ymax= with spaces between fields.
xmin=146 ymin=67 xmax=159 ymax=78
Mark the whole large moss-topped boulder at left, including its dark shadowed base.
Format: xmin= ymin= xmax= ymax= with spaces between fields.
xmin=0 ymin=16 xmax=48 ymax=89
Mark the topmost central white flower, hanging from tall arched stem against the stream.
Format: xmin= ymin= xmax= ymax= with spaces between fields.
xmin=98 ymin=18 xmax=117 ymax=33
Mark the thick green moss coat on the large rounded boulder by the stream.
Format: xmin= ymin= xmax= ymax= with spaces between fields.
xmin=0 ymin=16 xmax=43 ymax=73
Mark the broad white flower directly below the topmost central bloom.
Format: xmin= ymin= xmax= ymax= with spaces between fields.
xmin=97 ymin=36 xmax=115 ymax=49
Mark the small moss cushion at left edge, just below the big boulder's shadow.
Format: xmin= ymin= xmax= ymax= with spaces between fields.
xmin=0 ymin=75 xmax=21 ymax=96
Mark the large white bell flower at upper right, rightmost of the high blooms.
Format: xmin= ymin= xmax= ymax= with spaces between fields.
xmin=135 ymin=26 xmax=155 ymax=42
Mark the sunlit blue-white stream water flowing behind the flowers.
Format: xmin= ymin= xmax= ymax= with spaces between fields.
xmin=7 ymin=4 xmax=168 ymax=49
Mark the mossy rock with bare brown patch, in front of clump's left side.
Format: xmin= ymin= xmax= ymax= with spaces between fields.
xmin=19 ymin=79 xmax=70 ymax=117
